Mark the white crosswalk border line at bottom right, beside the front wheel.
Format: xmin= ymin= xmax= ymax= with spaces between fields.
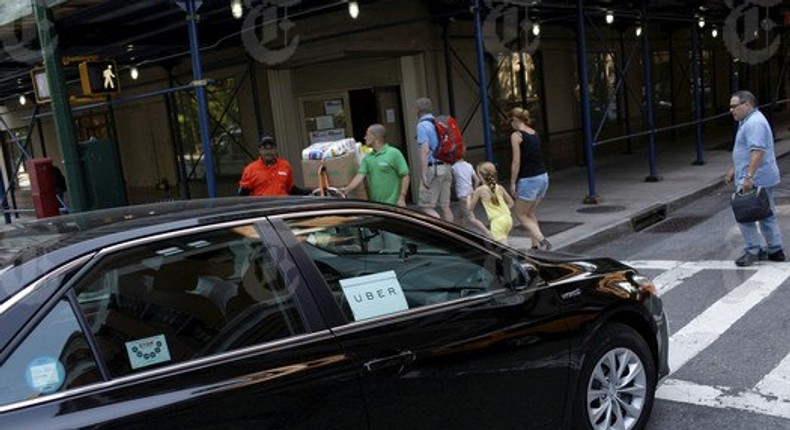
xmin=656 ymin=379 xmax=790 ymax=419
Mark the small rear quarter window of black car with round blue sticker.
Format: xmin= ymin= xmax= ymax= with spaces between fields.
xmin=0 ymin=300 xmax=101 ymax=405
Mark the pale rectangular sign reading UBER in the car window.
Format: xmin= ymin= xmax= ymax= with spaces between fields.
xmin=340 ymin=270 xmax=409 ymax=321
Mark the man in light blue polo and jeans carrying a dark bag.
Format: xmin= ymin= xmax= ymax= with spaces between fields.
xmin=725 ymin=91 xmax=785 ymax=266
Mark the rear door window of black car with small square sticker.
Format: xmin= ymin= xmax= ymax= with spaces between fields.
xmin=75 ymin=226 xmax=305 ymax=377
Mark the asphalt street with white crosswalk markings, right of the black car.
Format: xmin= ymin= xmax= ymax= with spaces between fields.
xmin=572 ymin=157 xmax=790 ymax=430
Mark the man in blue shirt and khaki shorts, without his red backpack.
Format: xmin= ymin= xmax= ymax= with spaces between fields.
xmin=414 ymin=97 xmax=453 ymax=222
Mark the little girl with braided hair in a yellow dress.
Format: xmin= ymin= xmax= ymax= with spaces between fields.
xmin=466 ymin=161 xmax=513 ymax=244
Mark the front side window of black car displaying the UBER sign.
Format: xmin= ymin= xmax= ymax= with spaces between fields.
xmin=286 ymin=215 xmax=504 ymax=321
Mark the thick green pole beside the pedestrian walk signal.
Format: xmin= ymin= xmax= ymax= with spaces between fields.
xmin=33 ymin=0 xmax=87 ymax=212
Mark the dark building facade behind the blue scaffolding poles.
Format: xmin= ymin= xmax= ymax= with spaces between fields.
xmin=0 ymin=0 xmax=789 ymax=207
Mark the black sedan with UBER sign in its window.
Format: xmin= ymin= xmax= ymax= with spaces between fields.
xmin=0 ymin=198 xmax=668 ymax=430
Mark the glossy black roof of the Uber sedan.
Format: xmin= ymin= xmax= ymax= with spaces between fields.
xmin=0 ymin=197 xmax=408 ymax=303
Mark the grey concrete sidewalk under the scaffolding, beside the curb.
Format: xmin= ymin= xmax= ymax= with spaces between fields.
xmin=509 ymin=115 xmax=790 ymax=253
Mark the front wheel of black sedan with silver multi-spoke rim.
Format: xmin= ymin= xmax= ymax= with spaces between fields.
xmin=573 ymin=323 xmax=656 ymax=430
